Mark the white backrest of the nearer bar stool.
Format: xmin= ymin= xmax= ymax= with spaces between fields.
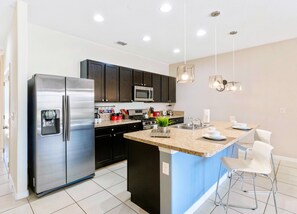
xmin=253 ymin=141 xmax=273 ymax=174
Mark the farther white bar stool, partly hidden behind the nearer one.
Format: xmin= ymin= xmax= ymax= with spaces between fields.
xmin=236 ymin=129 xmax=278 ymax=191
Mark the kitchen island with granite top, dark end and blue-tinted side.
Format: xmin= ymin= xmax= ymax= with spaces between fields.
xmin=124 ymin=122 xmax=256 ymax=214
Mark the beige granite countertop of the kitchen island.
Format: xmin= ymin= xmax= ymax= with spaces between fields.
xmin=124 ymin=122 xmax=257 ymax=157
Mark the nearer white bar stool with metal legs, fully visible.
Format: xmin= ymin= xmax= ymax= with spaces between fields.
xmin=215 ymin=141 xmax=277 ymax=213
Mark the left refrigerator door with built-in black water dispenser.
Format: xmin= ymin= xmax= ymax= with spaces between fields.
xmin=34 ymin=74 xmax=66 ymax=194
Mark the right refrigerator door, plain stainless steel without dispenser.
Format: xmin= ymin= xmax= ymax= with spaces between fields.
xmin=66 ymin=77 xmax=95 ymax=183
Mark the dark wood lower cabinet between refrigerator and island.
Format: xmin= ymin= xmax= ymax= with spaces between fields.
xmin=95 ymin=123 xmax=142 ymax=169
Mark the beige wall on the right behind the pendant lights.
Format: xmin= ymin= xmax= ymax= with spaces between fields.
xmin=170 ymin=39 xmax=297 ymax=158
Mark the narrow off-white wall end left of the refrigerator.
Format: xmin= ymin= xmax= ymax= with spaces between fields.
xmin=4 ymin=1 xmax=28 ymax=199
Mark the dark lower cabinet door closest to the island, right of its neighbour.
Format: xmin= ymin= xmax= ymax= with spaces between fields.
xmin=112 ymin=132 xmax=127 ymax=161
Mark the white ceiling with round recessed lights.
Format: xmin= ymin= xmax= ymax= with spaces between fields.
xmin=0 ymin=0 xmax=297 ymax=63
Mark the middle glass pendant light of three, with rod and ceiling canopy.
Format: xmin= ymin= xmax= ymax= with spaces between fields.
xmin=208 ymin=11 xmax=224 ymax=89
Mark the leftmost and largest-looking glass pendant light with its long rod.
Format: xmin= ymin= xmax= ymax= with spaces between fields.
xmin=176 ymin=0 xmax=195 ymax=83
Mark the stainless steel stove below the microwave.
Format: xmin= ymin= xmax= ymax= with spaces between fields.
xmin=128 ymin=109 xmax=156 ymax=130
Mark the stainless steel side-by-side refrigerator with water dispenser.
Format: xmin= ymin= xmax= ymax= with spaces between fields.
xmin=28 ymin=74 xmax=95 ymax=196
